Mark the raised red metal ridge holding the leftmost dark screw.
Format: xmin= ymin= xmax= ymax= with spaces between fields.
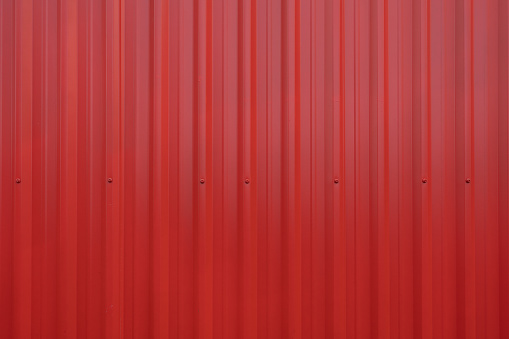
xmin=11 ymin=0 xmax=33 ymax=337
